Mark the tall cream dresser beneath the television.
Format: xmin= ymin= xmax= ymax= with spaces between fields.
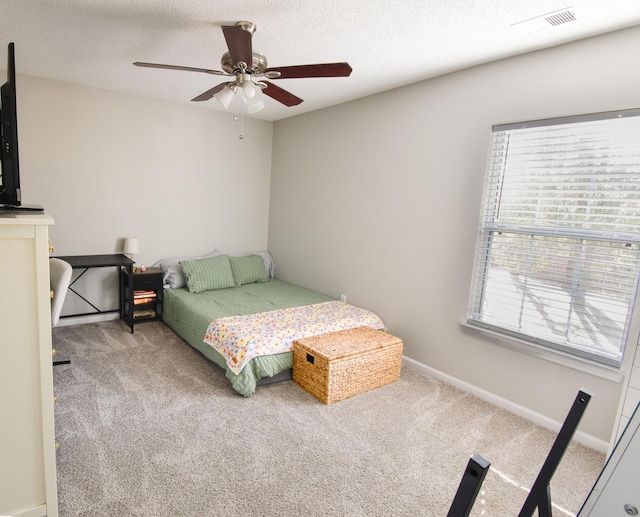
xmin=0 ymin=213 xmax=58 ymax=517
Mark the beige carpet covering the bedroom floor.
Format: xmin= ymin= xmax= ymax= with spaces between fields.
xmin=53 ymin=321 xmax=605 ymax=517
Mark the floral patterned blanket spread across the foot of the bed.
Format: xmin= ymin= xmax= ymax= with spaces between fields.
xmin=204 ymin=301 xmax=384 ymax=375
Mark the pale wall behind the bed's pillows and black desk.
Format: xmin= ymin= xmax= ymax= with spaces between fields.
xmin=17 ymin=75 xmax=273 ymax=313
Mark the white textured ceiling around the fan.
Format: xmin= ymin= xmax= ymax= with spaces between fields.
xmin=0 ymin=0 xmax=640 ymax=120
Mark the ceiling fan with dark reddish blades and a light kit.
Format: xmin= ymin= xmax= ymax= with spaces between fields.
xmin=133 ymin=21 xmax=351 ymax=113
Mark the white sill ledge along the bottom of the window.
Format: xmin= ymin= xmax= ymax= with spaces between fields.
xmin=460 ymin=321 xmax=624 ymax=382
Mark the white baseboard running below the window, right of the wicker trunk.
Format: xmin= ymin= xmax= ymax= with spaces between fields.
xmin=402 ymin=356 xmax=609 ymax=454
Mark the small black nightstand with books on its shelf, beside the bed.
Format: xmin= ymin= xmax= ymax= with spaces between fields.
xmin=120 ymin=267 xmax=163 ymax=334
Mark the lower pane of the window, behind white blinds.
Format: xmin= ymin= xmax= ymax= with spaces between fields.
xmin=472 ymin=233 xmax=639 ymax=363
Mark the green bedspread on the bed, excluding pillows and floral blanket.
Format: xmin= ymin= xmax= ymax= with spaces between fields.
xmin=162 ymin=278 xmax=333 ymax=397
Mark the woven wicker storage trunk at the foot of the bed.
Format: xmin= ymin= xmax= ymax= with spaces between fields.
xmin=293 ymin=327 xmax=402 ymax=404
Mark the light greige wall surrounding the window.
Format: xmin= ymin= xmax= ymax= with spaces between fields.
xmin=269 ymin=28 xmax=640 ymax=442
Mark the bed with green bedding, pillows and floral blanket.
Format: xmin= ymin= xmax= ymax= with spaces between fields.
xmin=155 ymin=250 xmax=384 ymax=397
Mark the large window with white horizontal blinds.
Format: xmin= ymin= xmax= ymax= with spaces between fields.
xmin=468 ymin=109 xmax=640 ymax=366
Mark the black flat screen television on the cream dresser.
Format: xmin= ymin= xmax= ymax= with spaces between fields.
xmin=0 ymin=43 xmax=42 ymax=212
